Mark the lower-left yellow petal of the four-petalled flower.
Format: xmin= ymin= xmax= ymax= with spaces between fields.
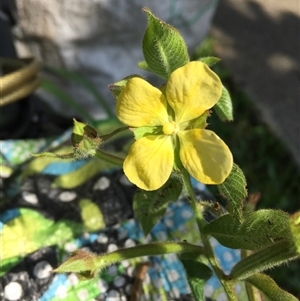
xmin=123 ymin=135 xmax=174 ymax=190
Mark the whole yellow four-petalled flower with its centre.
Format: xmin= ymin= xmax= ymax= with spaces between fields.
xmin=116 ymin=62 xmax=233 ymax=190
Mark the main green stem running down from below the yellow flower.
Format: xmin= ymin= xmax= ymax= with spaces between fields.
xmin=182 ymin=169 xmax=237 ymax=301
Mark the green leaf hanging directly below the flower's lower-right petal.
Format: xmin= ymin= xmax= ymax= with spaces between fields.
xmin=218 ymin=163 xmax=247 ymax=222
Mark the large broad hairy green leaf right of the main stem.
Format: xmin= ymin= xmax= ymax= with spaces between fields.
xmin=203 ymin=209 xmax=291 ymax=250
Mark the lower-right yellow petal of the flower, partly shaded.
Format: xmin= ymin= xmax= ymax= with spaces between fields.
xmin=178 ymin=129 xmax=233 ymax=184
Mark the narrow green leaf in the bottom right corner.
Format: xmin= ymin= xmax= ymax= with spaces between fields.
xmin=246 ymin=274 xmax=298 ymax=301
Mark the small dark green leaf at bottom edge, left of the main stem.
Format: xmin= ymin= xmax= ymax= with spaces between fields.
xmin=180 ymin=254 xmax=213 ymax=301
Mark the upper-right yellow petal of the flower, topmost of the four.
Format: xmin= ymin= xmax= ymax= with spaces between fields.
xmin=166 ymin=62 xmax=222 ymax=123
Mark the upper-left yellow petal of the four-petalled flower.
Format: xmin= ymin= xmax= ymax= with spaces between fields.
xmin=116 ymin=77 xmax=168 ymax=127
